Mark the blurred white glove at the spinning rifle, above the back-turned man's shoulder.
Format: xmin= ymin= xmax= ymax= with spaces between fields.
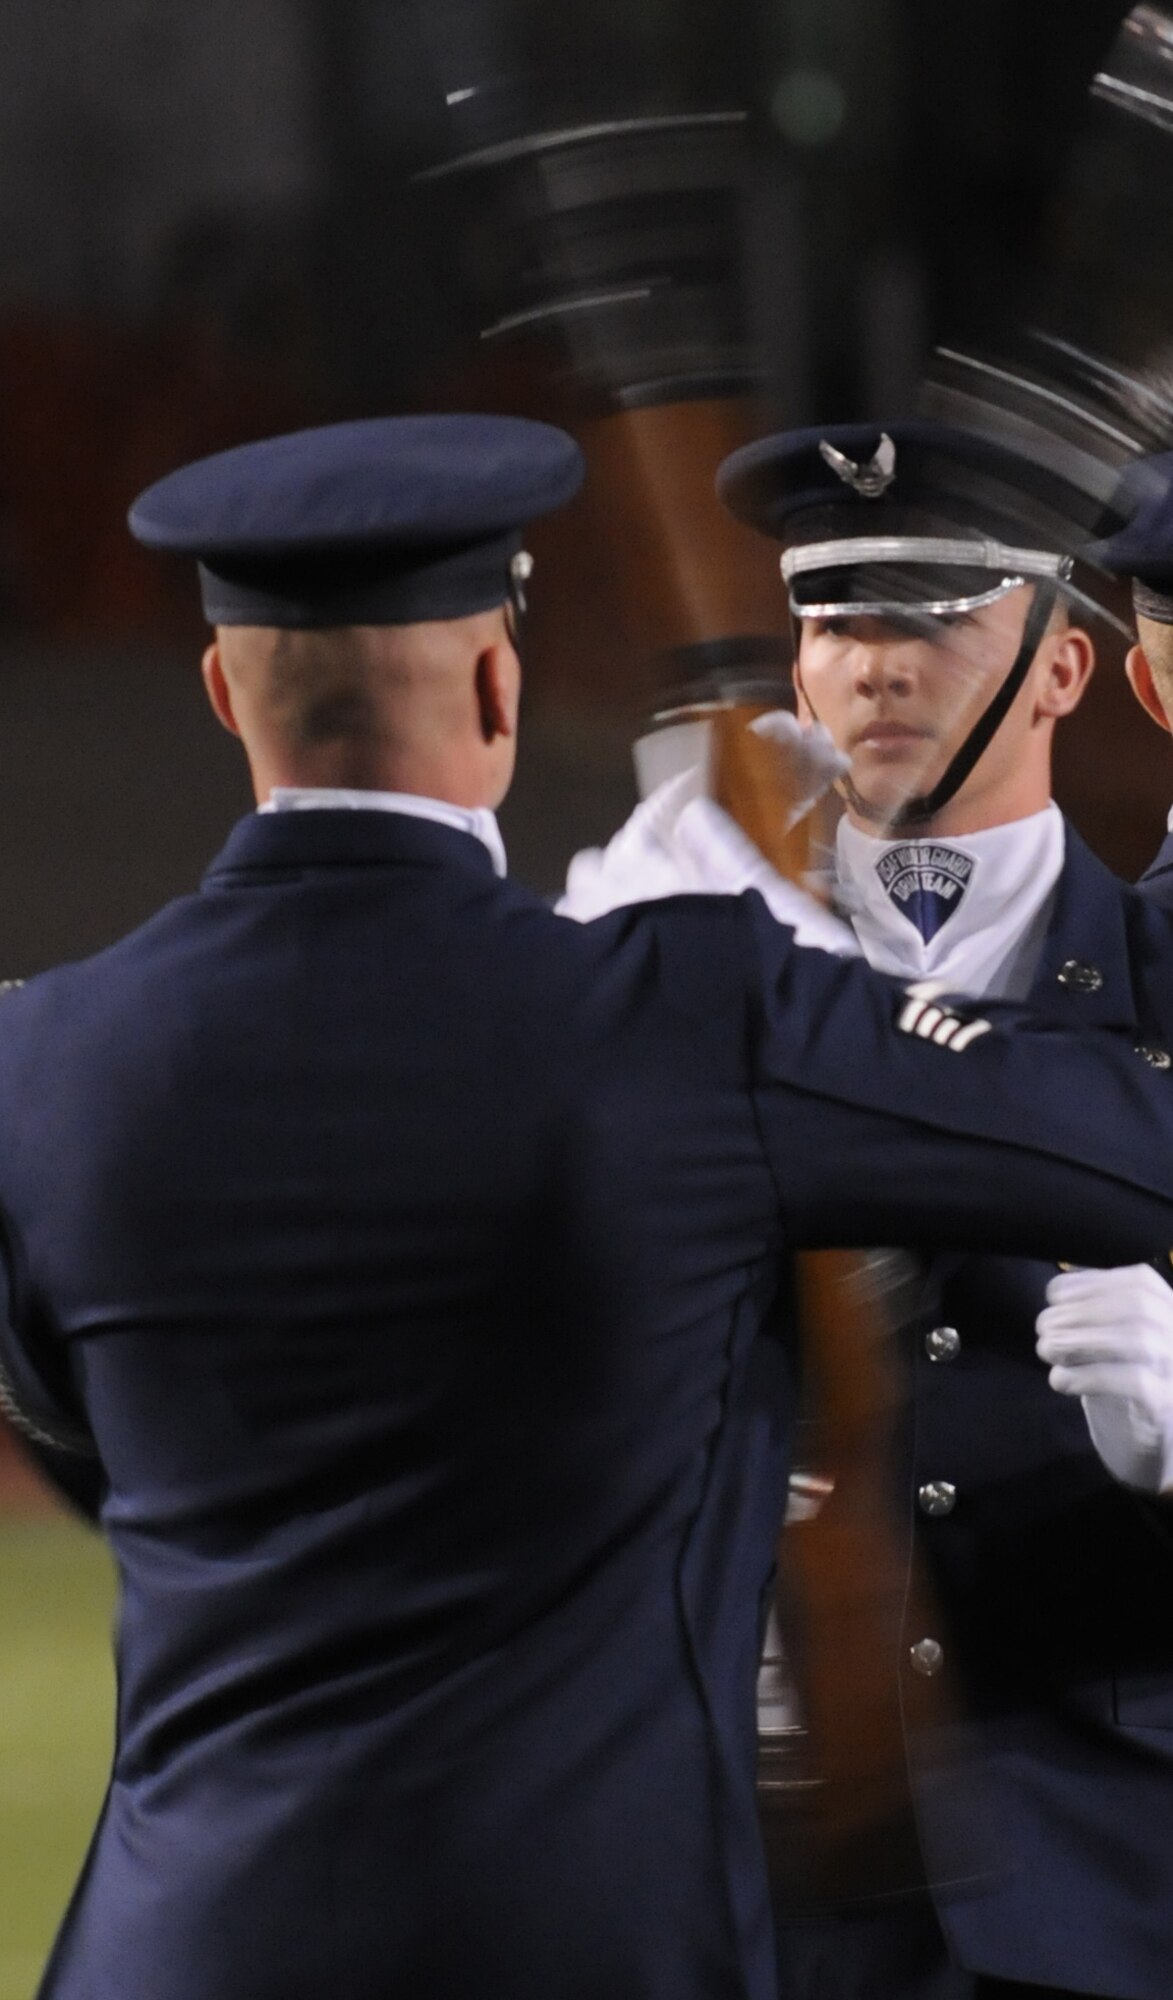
xmin=556 ymin=772 xmax=859 ymax=954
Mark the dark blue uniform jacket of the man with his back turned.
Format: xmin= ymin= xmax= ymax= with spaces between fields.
xmin=0 ymin=812 xmax=1173 ymax=2000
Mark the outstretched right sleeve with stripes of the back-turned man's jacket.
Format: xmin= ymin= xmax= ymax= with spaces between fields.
xmin=743 ymin=894 xmax=1173 ymax=1264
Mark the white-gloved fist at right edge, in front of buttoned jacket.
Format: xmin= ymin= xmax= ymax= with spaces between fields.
xmin=1035 ymin=1264 xmax=1173 ymax=1494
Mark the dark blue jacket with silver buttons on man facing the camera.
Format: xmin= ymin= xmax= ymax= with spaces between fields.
xmin=905 ymin=828 xmax=1173 ymax=2000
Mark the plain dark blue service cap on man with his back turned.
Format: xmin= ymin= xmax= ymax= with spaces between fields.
xmin=128 ymin=416 xmax=582 ymax=628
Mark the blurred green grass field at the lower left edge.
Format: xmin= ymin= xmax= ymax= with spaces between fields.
xmin=0 ymin=1516 xmax=114 ymax=2000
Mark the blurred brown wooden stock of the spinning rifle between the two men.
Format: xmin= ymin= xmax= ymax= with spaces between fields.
xmin=589 ymin=402 xmax=935 ymax=1902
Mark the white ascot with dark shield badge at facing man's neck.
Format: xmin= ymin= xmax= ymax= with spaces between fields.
xmin=839 ymin=804 xmax=1065 ymax=1000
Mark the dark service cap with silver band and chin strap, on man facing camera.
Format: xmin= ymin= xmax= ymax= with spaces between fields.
xmin=717 ymin=420 xmax=1103 ymax=826
